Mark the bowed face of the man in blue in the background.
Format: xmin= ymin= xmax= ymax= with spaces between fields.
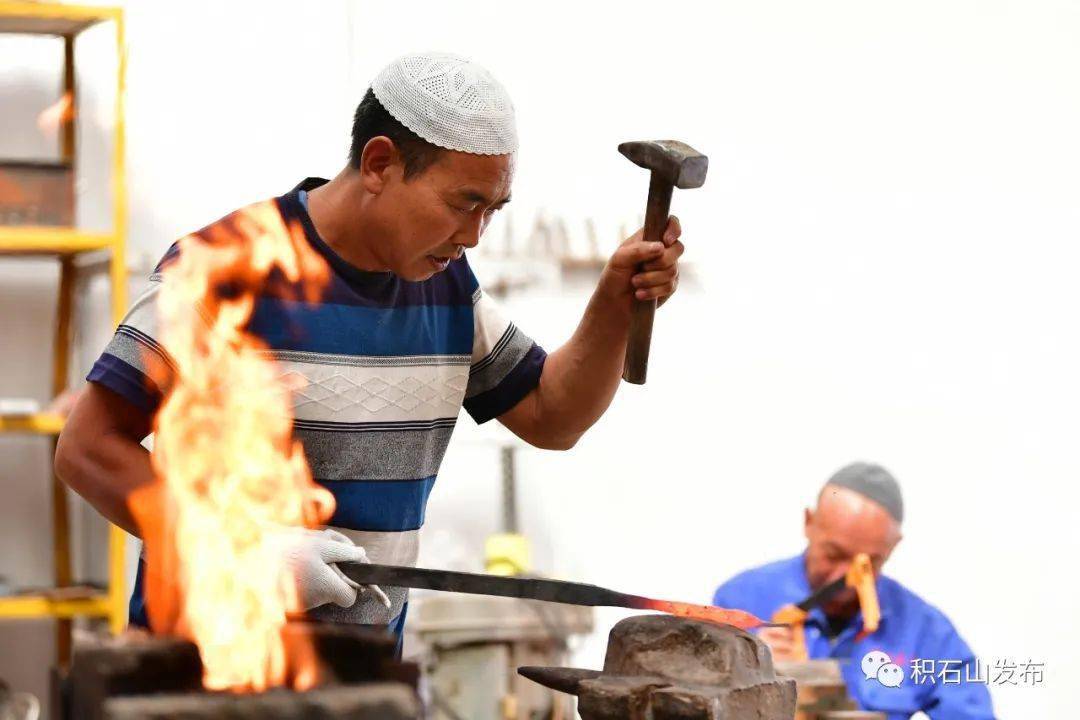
xmin=806 ymin=485 xmax=901 ymax=617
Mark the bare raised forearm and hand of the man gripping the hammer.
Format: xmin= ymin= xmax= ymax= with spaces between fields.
xmin=498 ymin=216 xmax=684 ymax=450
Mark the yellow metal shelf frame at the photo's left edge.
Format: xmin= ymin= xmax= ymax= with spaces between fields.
xmin=0 ymin=0 xmax=127 ymax=643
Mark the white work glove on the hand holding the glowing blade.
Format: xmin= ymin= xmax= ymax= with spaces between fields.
xmin=273 ymin=528 xmax=390 ymax=610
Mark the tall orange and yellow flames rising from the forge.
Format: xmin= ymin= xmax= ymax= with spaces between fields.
xmin=132 ymin=202 xmax=334 ymax=691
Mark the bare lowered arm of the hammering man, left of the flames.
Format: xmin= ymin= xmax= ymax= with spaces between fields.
xmin=55 ymin=382 xmax=154 ymax=536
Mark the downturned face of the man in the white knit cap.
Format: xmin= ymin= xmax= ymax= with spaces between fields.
xmin=365 ymin=150 xmax=514 ymax=281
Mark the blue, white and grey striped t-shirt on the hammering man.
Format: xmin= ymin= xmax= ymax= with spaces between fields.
xmin=86 ymin=178 xmax=546 ymax=627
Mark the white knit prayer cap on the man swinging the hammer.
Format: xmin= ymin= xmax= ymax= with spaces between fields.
xmin=372 ymin=53 xmax=517 ymax=155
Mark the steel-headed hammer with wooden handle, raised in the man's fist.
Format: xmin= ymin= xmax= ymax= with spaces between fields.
xmin=619 ymin=140 xmax=708 ymax=385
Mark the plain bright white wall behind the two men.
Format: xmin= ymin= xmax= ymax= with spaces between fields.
xmin=3 ymin=0 xmax=1080 ymax=718
